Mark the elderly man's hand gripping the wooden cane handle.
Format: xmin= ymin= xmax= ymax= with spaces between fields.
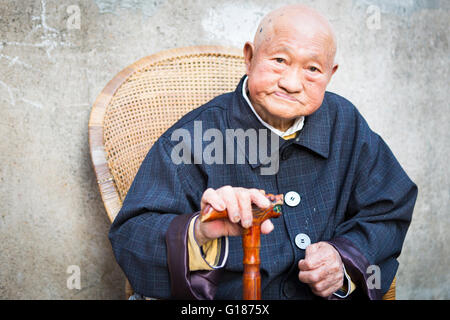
xmin=194 ymin=186 xmax=274 ymax=245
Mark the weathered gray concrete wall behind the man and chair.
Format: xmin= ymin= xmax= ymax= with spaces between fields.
xmin=0 ymin=0 xmax=450 ymax=299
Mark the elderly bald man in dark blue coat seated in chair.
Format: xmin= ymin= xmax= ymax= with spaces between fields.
xmin=110 ymin=5 xmax=417 ymax=299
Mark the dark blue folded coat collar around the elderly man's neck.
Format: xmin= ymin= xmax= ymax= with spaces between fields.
xmin=227 ymin=76 xmax=331 ymax=168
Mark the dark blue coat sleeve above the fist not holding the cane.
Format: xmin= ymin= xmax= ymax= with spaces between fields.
xmin=329 ymin=116 xmax=417 ymax=299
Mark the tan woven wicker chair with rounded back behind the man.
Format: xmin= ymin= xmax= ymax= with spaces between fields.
xmin=89 ymin=46 xmax=395 ymax=299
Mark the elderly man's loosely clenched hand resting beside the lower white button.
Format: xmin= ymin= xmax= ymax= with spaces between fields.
xmin=298 ymin=242 xmax=344 ymax=298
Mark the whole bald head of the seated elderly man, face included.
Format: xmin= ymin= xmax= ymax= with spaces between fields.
xmin=243 ymin=5 xmax=338 ymax=131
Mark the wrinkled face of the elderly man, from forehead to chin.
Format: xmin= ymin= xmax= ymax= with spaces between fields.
xmin=244 ymin=18 xmax=337 ymax=123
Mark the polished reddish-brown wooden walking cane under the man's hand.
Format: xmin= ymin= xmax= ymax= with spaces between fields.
xmin=200 ymin=194 xmax=283 ymax=300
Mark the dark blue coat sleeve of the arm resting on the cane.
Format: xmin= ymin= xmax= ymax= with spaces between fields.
xmin=109 ymin=137 xmax=215 ymax=299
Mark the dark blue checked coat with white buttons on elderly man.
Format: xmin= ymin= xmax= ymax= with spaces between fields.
xmin=109 ymin=75 xmax=417 ymax=299
